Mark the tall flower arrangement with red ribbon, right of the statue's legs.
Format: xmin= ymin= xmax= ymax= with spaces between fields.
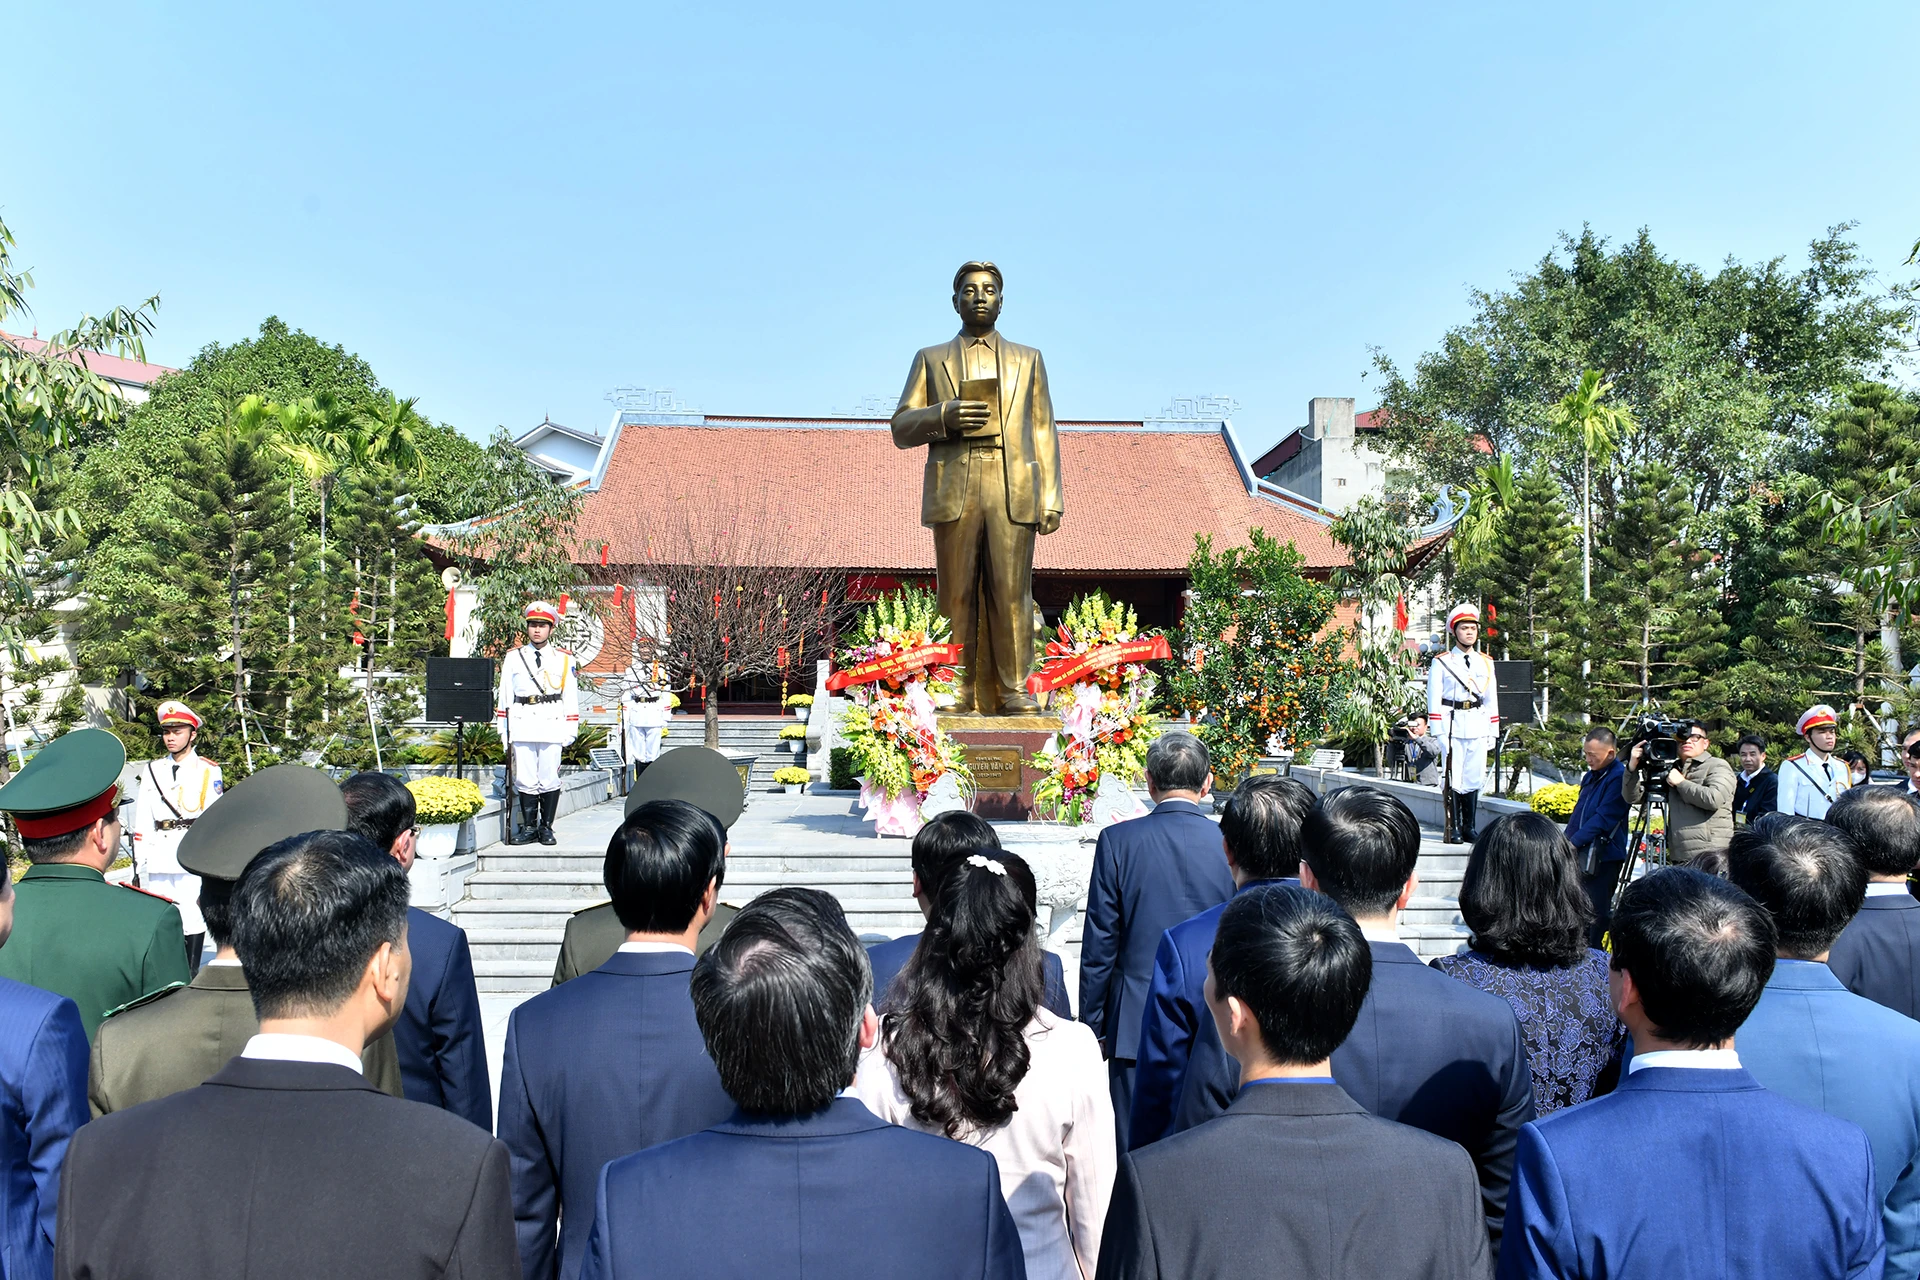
xmin=1027 ymin=591 xmax=1169 ymax=823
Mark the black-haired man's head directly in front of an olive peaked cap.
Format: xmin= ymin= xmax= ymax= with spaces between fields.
xmin=603 ymin=800 xmax=726 ymax=933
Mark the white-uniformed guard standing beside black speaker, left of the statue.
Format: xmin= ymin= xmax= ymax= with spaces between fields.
xmin=493 ymin=601 xmax=580 ymax=844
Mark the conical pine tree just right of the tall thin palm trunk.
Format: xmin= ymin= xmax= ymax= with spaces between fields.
xmin=1586 ymin=462 xmax=1728 ymax=725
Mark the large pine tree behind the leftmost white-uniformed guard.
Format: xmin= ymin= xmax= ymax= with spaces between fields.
xmin=81 ymin=426 xmax=314 ymax=771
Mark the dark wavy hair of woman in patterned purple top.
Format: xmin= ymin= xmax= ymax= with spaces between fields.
xmin=1459 ymin=814 xmax=1594 ymax=969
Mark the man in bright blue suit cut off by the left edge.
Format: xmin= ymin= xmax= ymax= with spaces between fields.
xmin=0 ymin=852 xmax=86 ymax=1276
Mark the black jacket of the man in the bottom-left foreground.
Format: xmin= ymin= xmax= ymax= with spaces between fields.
xmin=54 ymin=1057 xmax=520 ymax=1280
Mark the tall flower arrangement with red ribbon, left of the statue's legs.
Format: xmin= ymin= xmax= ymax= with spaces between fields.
xmin=828 ymin=587 xmax=973 ymax=837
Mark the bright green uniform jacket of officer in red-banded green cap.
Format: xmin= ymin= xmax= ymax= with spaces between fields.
xmin=0 ymin=862 xmax=188 ymax=1040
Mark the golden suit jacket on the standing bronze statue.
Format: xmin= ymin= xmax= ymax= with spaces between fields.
xmin=893 ymin=334 xmax=1066 ymax=528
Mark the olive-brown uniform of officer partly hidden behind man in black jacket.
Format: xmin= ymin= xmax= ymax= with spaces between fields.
xmin=86 ymin=965 xmax=403 ymax=1115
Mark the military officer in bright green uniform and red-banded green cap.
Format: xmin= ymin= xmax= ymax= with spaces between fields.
xmin=0 ymin=729 xmax=188 ymax=1040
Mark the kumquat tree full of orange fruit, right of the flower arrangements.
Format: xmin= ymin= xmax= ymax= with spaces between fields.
xmin=1167 ymin=530 xmax=1352 ymax=779
